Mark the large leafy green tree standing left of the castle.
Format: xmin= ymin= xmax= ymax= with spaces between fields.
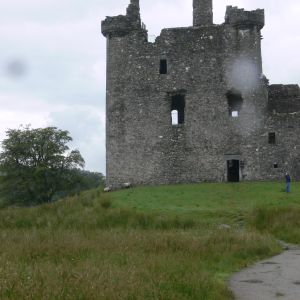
xmin=0 ymin=126 xmax=84 ymax=205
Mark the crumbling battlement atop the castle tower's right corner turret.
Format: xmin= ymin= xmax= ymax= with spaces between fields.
xmin=225 ymin=6 xmax=265 ymax=29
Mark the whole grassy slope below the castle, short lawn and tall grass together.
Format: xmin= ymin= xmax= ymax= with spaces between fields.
xmin=0 ymin=183 xmax=300 ymax=300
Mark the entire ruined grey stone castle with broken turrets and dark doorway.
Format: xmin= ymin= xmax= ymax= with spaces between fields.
xmin=102 ymin=0 xmax=300 ymax=188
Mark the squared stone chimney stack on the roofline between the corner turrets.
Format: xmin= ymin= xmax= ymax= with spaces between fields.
xmin=193 ymin=0 xmax=213 ymax=27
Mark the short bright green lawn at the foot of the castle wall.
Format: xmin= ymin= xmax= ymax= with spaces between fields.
xmin=112 ymin=182 xmax=300 ymax=224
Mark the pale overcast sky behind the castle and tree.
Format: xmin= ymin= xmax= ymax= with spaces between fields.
xmin=0 ymin=0 xmax=300 ymax=174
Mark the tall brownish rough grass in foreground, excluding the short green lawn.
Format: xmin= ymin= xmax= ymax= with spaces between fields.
xmin=0 ymin=185 xmax=288 ymax=300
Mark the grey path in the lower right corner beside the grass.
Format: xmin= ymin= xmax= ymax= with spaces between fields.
xmin=229 ymin=245 xmax=300 ymax=300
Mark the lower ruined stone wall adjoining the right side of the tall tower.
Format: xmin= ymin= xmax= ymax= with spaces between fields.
xmin=265 ymin=84 xmax=300 ymax=179
